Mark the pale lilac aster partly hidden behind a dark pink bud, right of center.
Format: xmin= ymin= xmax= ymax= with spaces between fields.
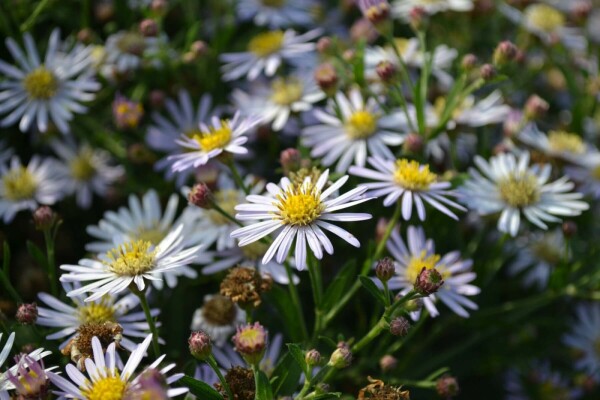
xmin=387 ymin=226 xmax=480 ymax=319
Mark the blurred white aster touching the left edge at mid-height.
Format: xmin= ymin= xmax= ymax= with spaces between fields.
xmin=0 ymin=156 xmax=65 ymax=224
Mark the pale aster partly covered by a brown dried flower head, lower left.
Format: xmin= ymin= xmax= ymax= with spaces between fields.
xmin=36 ymin=283 xmax=160 ymax=351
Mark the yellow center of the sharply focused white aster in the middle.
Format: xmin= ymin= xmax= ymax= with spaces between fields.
xmin=274 ymin=184 xmax=325 ymax=226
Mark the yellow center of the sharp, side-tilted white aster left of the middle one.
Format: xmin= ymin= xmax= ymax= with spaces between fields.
xmin=106 ymin=240 xmax=156 ymax=276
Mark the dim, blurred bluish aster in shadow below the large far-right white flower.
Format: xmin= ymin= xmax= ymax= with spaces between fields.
xmin=508 ymin=229 xmax=571 ymax=289
